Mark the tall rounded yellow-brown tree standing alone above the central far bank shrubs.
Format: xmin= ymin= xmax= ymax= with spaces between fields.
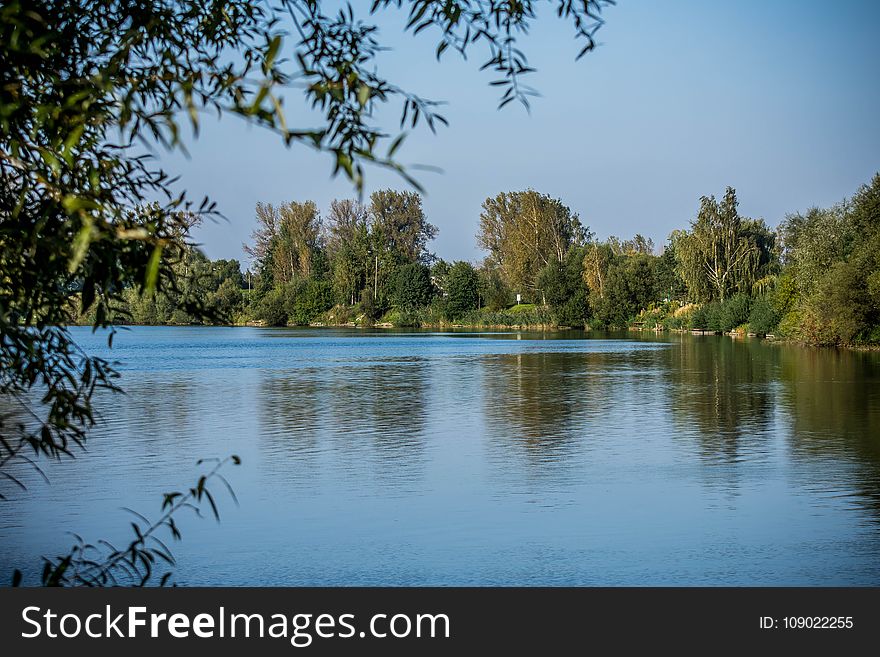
xmin=477 ymin=189 xmax=587 ymax=292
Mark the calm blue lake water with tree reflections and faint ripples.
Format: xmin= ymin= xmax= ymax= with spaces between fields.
xmin=0 ymin=327 xmax=880 ymax=586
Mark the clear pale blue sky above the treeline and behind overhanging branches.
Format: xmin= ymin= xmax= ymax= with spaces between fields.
xmin=160 ymin=0 xmax=880 ymax=262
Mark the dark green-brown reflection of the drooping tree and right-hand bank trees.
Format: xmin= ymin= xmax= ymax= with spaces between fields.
xmin=663 ymin=335 xmax=880 ymax=520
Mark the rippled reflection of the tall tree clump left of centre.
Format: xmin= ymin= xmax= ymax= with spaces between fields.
xmin=259 ymin=357 xmax=431 ymax=486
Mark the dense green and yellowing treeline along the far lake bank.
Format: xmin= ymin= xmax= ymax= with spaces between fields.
xmin=94 ymin=174 xmax=880 ymax=345
